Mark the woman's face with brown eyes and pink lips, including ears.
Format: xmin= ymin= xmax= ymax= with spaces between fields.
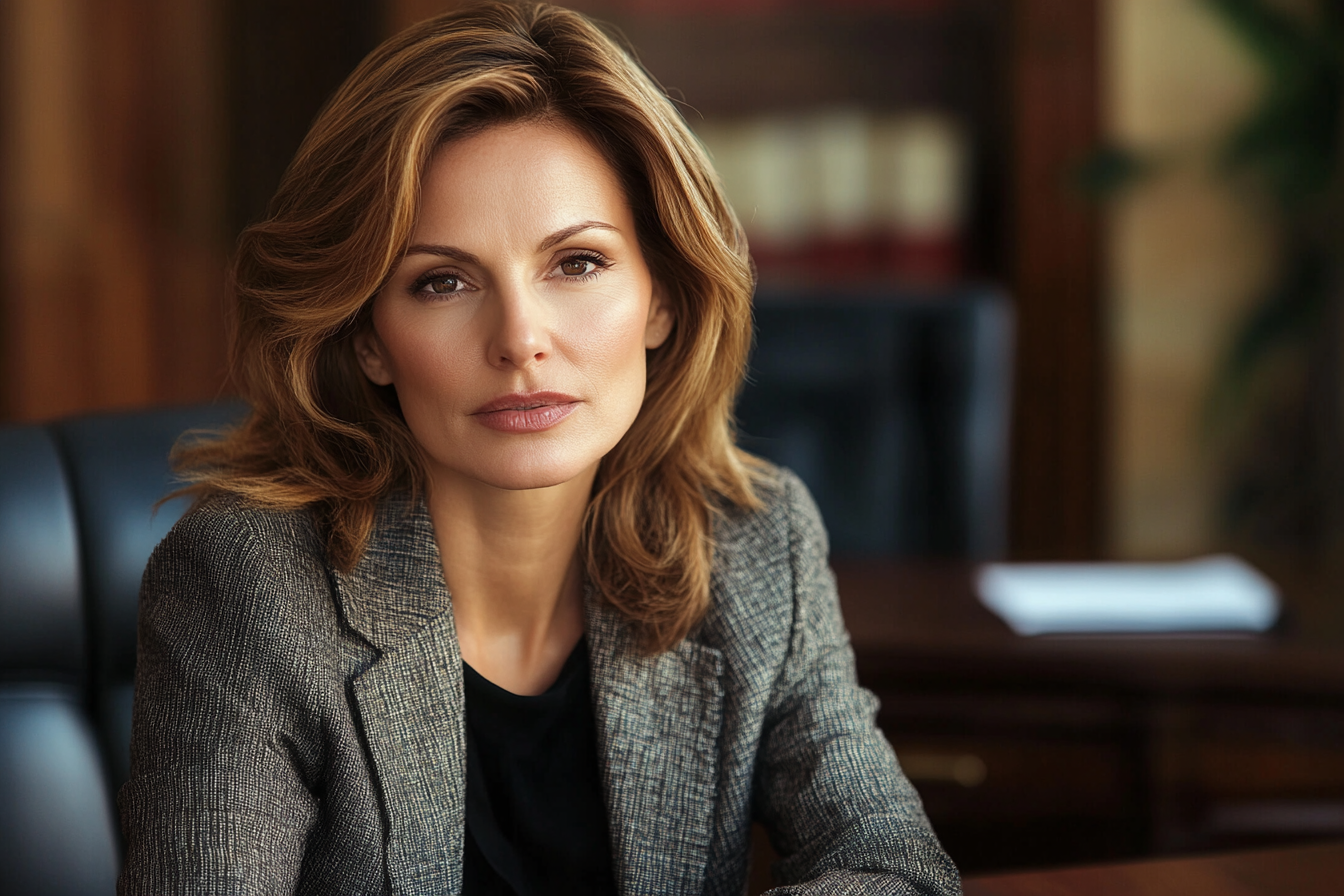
xmin=355 ymin=122 xmax=672 ymax=489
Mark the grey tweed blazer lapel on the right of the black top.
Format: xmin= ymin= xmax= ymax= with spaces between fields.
xmin=586 ymin=588 xmax=723 ymax=896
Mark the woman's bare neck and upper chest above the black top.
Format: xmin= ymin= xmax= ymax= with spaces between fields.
xmin=429 ymin=469 xmax=595 ymax=695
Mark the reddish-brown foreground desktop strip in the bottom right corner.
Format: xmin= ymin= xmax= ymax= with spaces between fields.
xmin=965 ymin=842 xmax=1344 ymax=896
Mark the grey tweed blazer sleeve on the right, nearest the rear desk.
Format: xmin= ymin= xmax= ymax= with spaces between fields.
xmin=753 ymin=473 xmax=961 ymax=896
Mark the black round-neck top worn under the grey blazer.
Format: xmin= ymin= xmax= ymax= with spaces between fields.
xmin=462 ymin=639 xmax=616 ymax=896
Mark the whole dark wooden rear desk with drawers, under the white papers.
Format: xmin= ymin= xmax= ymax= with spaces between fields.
xmin=835 ymin=560 xmax=1344 ymax=873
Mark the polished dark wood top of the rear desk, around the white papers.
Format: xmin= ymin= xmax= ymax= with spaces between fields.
xmin=835 ymin=559 xmax=1344 ymax=699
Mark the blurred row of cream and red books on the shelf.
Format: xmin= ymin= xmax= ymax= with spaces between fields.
xmin=696 ymin=106 xmax=969 ymax=286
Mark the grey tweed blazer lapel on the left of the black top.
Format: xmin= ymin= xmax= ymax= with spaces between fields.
xmin=335 ymin=498 xmax=466 ymax=896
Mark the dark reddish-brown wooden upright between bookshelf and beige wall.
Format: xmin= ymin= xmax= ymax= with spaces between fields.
xmin=1005 ymin=0 xmax=1106 ymax=559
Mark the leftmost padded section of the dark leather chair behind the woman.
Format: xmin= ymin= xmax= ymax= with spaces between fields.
xmin=0 ymin=426 xmax=117 ymax=895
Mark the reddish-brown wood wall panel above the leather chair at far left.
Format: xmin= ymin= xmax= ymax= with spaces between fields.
xmin=0 ymin=0 xmax=227 ymax=420
